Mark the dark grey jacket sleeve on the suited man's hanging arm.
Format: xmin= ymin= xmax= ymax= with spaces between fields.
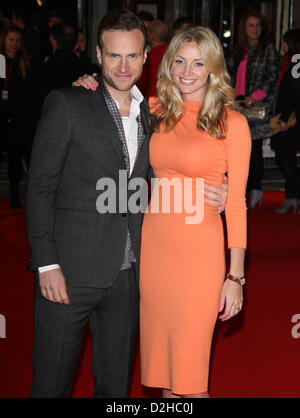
xmin=26 ymin=90 xmax=71 ymax=270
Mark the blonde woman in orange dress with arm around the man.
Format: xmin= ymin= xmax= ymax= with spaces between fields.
xmin=140 ymin=27 xmax=251 ymax=398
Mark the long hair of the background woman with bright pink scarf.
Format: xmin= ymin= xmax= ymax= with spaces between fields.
xmin=234 ymin=11 xmax=270 ymax=61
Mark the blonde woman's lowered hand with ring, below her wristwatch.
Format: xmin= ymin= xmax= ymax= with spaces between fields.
xmin=219 ymin=279 xmax=243 ymax=321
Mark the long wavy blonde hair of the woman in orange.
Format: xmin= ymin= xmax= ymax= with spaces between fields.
xmin=155 ymin=26 xmax=235 ymax=138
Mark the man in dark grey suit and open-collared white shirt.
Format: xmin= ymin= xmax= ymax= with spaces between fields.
xmin=26 ymin=12 xmax=227 ymax=397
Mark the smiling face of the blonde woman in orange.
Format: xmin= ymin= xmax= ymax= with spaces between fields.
xmin=171 ymin=42 xmax=209 ymax=103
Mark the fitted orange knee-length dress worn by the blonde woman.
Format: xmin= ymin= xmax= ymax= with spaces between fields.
xmin=140 ymin=102 xmax=251 ymax=394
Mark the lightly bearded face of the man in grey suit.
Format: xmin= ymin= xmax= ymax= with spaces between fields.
xmin=97 ymin=29 xmax=147 ymax=95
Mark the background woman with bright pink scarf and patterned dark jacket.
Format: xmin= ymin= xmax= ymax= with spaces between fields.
xmin=228 ymin=11 xmax=279 ymax=208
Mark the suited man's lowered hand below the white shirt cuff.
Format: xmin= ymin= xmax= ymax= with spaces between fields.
xmin=40 ymin=269 xmax=70 ymax=305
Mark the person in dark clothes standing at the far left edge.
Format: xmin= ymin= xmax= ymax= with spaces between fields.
xmin=0 ymin=24 xmax=31 ymax=209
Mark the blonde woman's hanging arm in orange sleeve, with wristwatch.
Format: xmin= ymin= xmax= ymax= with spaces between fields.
xmin=219 ymin=112 xmax=251 ymax=321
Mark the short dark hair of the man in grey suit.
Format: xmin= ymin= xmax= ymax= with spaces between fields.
xmin=97 ymin=10 xmax=147 ymax=50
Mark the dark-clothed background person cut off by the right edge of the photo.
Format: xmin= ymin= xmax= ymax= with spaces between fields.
xmin=271 ymin=29 xmax=300 ymax=215
